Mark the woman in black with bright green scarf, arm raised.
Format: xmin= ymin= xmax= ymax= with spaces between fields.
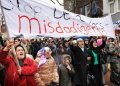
xmin=89 ymin=39 xmax=105 ymax=86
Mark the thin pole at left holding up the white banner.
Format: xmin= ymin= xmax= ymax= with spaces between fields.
xmin=0 ymin=0 xmax=20 ymax=68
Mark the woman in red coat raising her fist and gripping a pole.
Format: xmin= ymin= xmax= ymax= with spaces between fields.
xmin=0 ymin=40 xmax=37 ymax=86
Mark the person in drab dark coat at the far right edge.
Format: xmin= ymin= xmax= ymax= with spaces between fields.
xmin=107 ymin=38 xmax=120 ymax=85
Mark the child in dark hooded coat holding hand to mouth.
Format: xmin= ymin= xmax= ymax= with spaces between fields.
xmin=58 ymin=54 xmax=75 ymax=86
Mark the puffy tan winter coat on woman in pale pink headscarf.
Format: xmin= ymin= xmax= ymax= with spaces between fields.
xmin=35 ymin=57 xmax=59 ymax=86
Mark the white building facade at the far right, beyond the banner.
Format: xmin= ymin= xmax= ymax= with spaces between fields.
xmin=103 ymin=0 xmax=120 ymax=39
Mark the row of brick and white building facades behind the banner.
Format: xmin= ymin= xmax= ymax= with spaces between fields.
xmin=64 ymin=0 xmax=120 ymax=39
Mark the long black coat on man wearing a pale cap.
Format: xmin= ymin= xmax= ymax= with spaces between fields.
xmin=70 ymin=45 xmax=89 ymax=86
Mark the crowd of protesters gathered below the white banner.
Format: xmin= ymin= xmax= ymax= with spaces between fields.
xmin=0 ymin=29 xmax=120 ymax=86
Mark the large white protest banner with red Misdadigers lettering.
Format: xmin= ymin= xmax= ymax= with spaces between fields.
xmin=1 ymin=0 xmax=115 ymax=37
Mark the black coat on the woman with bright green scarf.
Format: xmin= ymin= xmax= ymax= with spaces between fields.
xmin=89 ymin=40 xmax=105 ymax=86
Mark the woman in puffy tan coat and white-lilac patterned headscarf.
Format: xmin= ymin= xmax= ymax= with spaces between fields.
xmin=35 ymin=47 xmax=59 ymax=86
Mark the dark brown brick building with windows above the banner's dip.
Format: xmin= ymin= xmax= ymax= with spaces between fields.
xmin=64 ymin=0 xmax=103 ymax=17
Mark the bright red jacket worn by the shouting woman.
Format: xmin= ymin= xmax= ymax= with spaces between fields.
xmin=0 ymin=51 xmax=37 ymax=86
